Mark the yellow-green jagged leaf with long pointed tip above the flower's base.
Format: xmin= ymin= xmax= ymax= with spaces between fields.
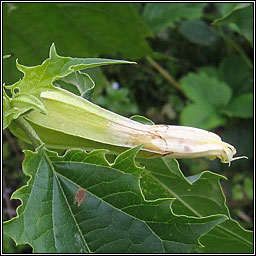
xmin=5 ymin=44 xmax=134 ymax=130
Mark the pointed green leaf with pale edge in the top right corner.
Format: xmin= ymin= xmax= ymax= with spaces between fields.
xmin=213 ymin=3 xmax=253 ymax=44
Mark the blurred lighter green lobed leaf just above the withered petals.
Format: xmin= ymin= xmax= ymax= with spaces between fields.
xmin=180 ymin=72 xmax=232 ymax=129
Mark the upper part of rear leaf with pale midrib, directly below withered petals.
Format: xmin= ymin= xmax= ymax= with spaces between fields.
xmin=138 ymin=158 xmax=229 ymax=217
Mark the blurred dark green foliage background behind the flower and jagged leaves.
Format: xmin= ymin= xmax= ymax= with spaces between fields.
xmin=3 ymin=3 xmax=254 ymax=253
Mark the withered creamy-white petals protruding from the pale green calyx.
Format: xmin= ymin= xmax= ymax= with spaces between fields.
xmin=143 ymin=125 xmax=246 ymax=164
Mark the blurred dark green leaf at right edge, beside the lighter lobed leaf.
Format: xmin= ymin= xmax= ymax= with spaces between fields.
xmin=222 ymin=93 xmax=253 ymax=118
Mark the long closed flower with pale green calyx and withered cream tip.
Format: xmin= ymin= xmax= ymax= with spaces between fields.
xmin=25 ymin=88 xmax=247 ymax=164
